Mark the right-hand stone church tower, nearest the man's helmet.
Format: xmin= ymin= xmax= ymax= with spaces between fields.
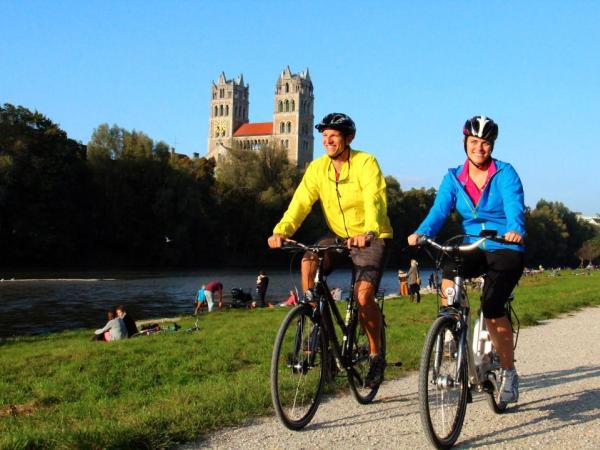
xmin=273 ymin=66 xmax=314 ymax=167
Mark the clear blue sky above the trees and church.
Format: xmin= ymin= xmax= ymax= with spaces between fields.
xmin=0 ymin=0 xmax=600 ymax=215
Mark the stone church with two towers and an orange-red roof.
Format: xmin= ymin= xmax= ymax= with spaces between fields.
xmin=207 ymin=67 xmax=314 ymax=166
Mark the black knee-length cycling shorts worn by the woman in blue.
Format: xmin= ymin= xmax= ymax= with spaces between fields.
xmin=444 ymin=249 xmax=524 ymax=319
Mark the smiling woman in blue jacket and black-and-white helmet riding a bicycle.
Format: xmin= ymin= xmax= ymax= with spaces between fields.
xmin=408 ymin=116 xmax=525 ymax=403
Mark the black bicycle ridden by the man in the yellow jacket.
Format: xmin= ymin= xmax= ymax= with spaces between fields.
xmin=271 ymin=240 xmax=385 ymax=430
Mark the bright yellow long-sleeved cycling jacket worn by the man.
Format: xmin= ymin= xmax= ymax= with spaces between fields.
xmin=273 ymin=149 xmax=393 ymax=239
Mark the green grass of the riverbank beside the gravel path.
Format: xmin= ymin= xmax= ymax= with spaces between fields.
xmin=0 ymin=271 xmax=600 ymax=449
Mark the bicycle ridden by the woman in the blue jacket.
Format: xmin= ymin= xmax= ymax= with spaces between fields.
xmin=418 ymin=233 xmax=520 ymax=448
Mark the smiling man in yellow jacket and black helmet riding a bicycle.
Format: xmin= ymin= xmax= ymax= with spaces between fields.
xmin=268 ymin=113 xmax=393 ymax=387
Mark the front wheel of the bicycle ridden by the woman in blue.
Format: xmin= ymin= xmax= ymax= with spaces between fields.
xmin=419 ymin=317 xmax=469 ymax=448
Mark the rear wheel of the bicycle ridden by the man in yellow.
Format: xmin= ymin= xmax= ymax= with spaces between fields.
xmin=347 ymin=317 xmax=386 ymax=405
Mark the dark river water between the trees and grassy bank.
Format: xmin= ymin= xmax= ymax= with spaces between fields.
xmin=0 ymin=271 xmax=428 ymax=337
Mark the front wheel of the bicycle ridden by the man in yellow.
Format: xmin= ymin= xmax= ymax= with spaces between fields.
xmin=271 ymin=305 xmax=327 ymax=430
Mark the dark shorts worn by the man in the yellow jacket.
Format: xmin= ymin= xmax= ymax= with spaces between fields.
xmin=304 ymin=236 xmax=391 ymax=290
